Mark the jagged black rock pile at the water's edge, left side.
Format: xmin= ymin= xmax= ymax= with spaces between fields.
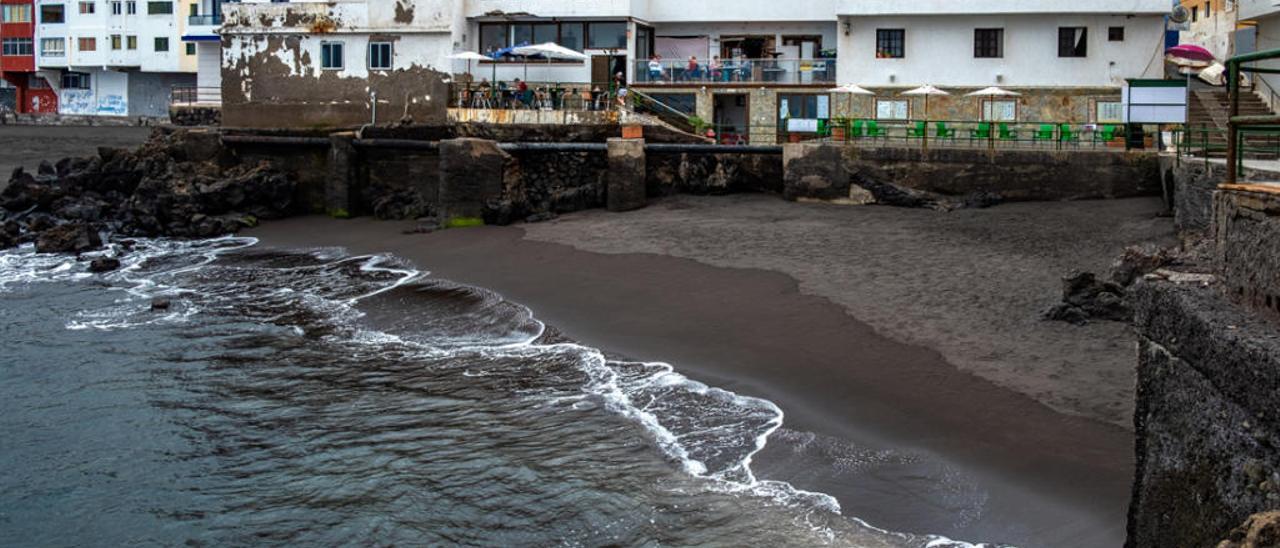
xmin=0 ymin=128 xmax=294 ymax=254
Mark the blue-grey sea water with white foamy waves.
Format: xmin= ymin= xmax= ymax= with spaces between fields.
xmin=0 ymin=237 xmax=993 ymax=547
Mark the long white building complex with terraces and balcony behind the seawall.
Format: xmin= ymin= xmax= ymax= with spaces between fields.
xmin=221 ymin=0 xmax=1172 ymax=142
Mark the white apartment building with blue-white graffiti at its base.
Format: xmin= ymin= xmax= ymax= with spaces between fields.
xmin=36 ymin=0 xmax=198 ymax=117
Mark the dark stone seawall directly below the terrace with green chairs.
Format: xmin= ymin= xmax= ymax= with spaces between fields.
xmin=783 ymin=143 xmax=1161 ymax=201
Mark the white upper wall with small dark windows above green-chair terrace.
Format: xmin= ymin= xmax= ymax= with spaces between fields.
xmin=838 ymin=15 xmax=1164 ymax=87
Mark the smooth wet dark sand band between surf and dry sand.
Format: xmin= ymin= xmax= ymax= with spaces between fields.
xmin=246 ymin=198 xmax=1162 ymax=545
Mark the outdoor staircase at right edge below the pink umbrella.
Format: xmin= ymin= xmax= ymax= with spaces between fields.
xmin=1187 ymin=90 xmax=1280 ymax=159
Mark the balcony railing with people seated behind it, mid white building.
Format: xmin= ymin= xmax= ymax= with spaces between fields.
xmin=635 ymin=59 xmax=836 ymax=86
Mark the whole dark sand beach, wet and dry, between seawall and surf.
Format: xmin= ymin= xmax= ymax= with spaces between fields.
xmin=250 ymin=196 xmax=1167 ymax=547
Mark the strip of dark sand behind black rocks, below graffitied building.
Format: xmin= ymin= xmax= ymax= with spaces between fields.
xmin=0 ymin=125 xmax=151 ymax=189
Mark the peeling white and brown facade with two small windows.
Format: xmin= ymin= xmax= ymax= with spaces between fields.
xmin=221 ymin=0 xmax=454 ymax=128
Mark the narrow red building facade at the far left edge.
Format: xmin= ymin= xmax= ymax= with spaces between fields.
xmin=0 ymin=0 xmax=58 ymax=113
